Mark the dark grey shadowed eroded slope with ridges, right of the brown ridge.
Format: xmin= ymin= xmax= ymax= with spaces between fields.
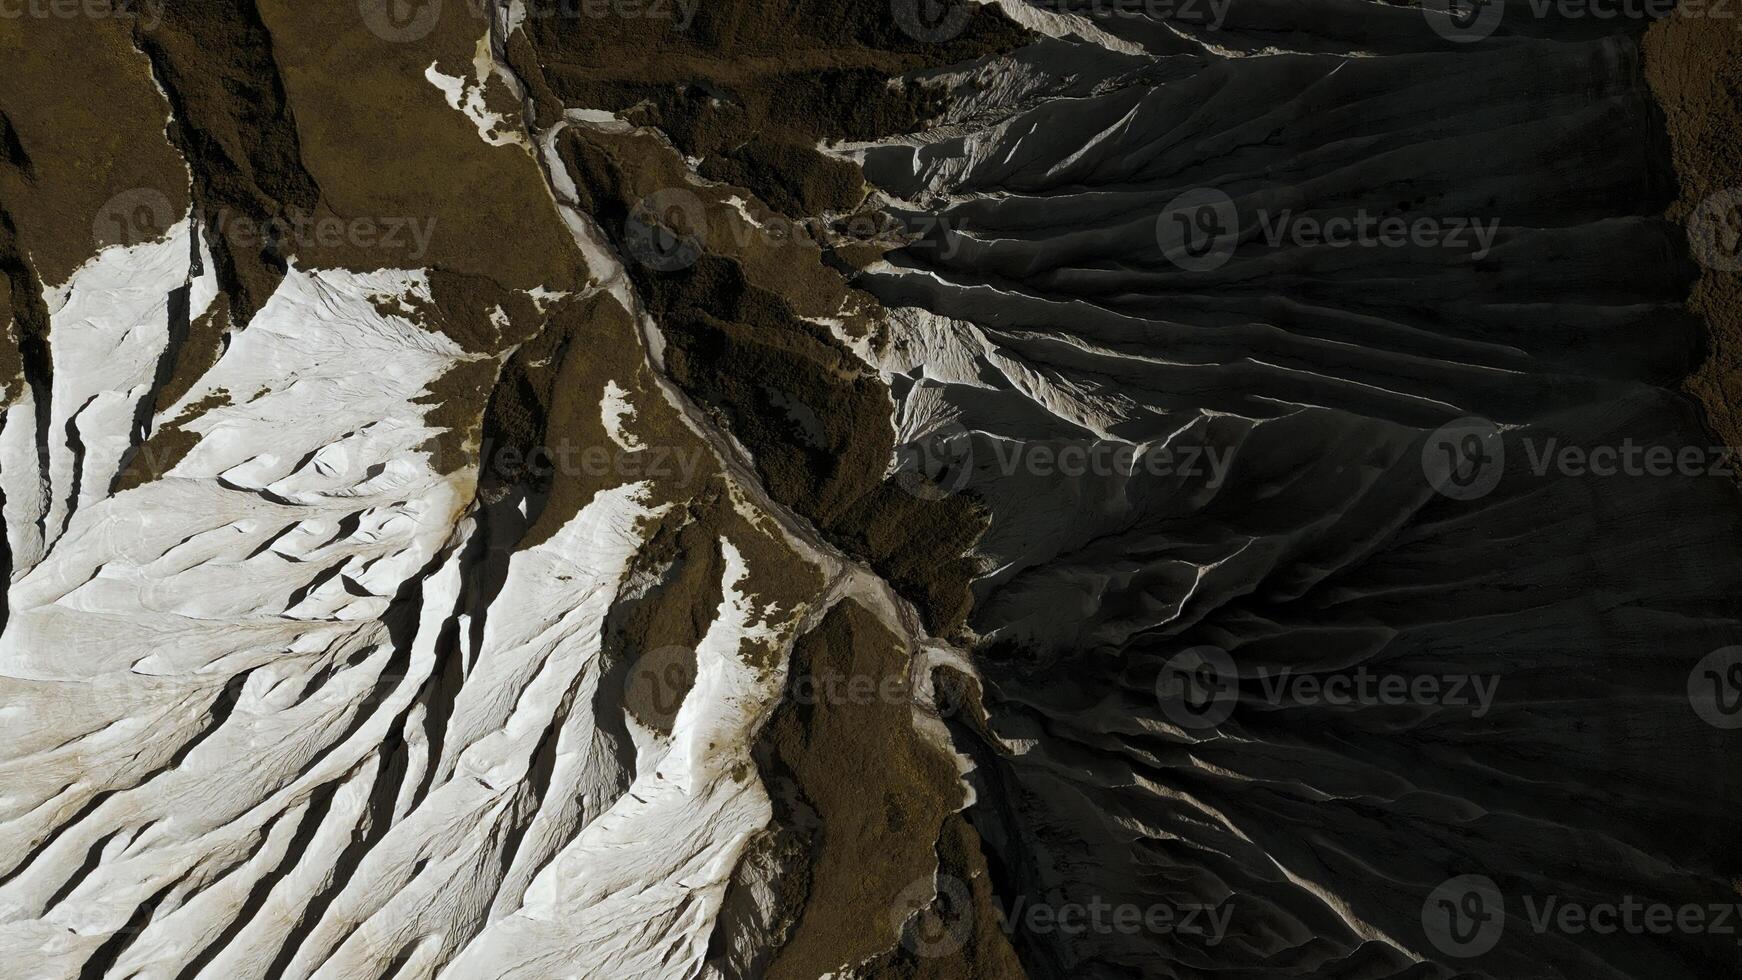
xmin=864 ymin=2 xmax=1742 ymax=978
